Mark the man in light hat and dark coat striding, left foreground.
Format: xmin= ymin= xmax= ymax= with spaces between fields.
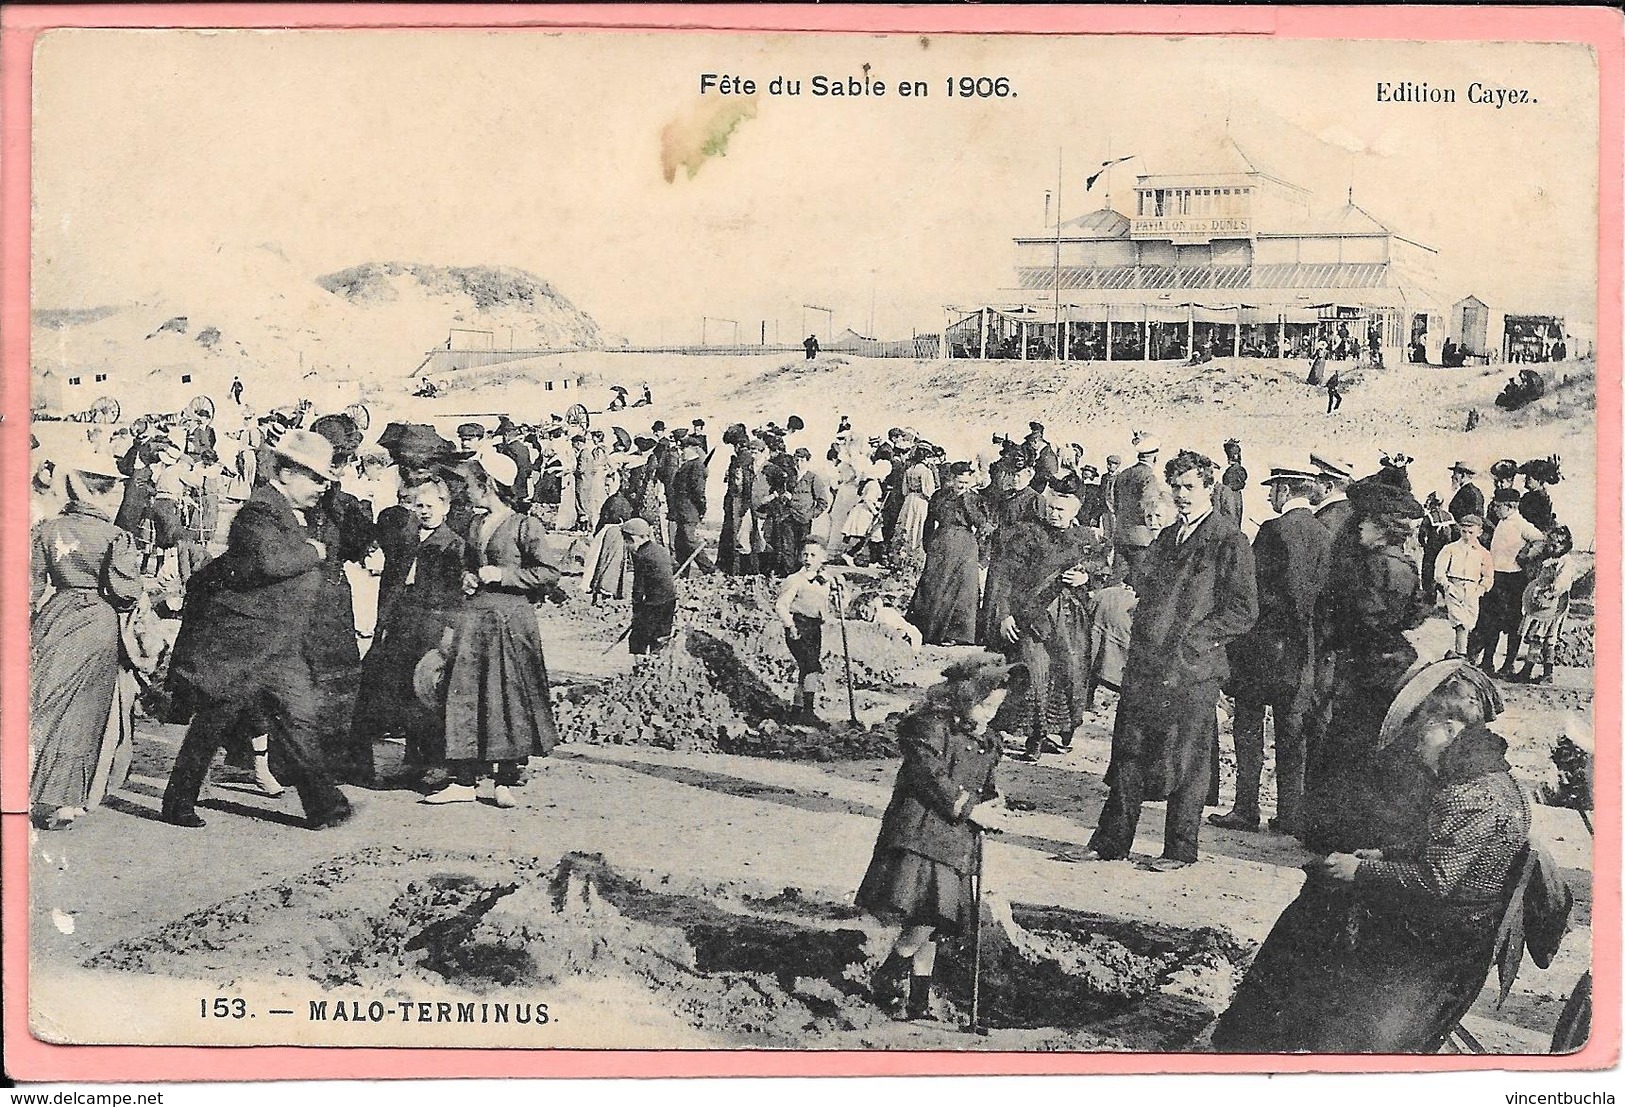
xmin=163 ymin=431 xmax=351 ymax=829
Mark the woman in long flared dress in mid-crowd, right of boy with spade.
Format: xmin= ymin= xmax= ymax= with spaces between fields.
xmin=907 ymin=462 xmax=988 ymax=645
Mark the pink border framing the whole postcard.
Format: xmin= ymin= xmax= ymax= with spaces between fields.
xmin=0 ymin=3 xmax=1625 ymax=1083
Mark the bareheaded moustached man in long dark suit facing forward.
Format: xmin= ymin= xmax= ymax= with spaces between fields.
xmin=1084 ymin=450 xmax=1258 ymax=871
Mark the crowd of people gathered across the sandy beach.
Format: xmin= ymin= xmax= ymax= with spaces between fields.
xmin=31 ymin=380 xmax=1578 ymax=1050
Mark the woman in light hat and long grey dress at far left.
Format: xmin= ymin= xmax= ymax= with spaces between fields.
xmin=28 ymin=450 xmax=143 ymax=831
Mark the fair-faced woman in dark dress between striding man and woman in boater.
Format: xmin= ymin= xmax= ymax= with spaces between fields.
xmin=351 ymin=473 xmax=465 ymax=771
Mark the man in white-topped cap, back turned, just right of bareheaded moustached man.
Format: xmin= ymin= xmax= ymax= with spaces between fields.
xmin=1207 ymin=468 xmax=1331 ymax=834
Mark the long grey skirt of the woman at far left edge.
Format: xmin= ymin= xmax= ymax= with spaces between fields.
xmin=28 ymin=588 xmax=119 ymax=808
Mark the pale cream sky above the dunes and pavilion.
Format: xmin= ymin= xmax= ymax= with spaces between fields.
xmin=34 ymin=31 xmax=1597 ymax=343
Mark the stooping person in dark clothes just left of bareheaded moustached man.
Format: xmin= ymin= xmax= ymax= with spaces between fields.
xmin=982 ymin=488 xmax=1105 ymax=761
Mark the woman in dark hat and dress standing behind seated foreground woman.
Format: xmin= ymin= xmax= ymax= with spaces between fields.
xmin=1303 ymin=476 xmax=1430 ymax=850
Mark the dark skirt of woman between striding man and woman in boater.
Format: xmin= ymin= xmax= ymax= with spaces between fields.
xmin=351 ymin=592 xmax=452 ymax=766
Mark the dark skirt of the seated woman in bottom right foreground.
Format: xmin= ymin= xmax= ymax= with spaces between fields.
xmin=1212 ymin=878 xmax=1500 ymax=1053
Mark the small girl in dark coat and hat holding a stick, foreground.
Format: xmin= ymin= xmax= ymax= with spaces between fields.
xmin=856 ymin=653 xmax=1012 ymax=1019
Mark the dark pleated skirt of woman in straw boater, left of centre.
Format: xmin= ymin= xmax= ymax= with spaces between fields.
xmin=445 ymin=592 xmax=559 ymax=761
